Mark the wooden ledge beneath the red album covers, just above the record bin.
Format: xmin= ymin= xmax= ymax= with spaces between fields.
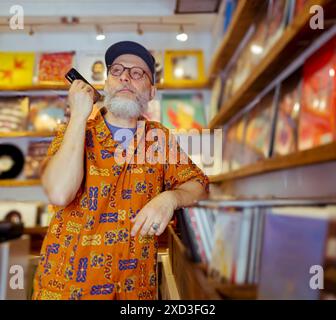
xmin=209 ymin=142 xmax=336 ymax=183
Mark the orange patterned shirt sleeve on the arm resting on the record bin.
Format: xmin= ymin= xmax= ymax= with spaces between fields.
xmin=164 ymin=134 xmax=209 ymax=193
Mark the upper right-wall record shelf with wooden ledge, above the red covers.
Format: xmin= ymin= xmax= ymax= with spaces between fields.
xmin=209 ymin=0 xmax=336 ymax=128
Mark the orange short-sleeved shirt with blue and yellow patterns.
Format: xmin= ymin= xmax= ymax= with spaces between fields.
xmin=33 ymin=108 xmax=209 ymax=300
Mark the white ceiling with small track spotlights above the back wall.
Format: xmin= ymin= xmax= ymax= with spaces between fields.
xmin=0 ymin=0 xmax=219 ymax=33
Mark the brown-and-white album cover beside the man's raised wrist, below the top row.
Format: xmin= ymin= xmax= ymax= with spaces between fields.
xmin=29 ymin=96 xmax=67 ymax=132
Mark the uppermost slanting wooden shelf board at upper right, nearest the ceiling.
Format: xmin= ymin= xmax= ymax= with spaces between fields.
xmin=209 ymin=0 xmax=260 ymax=80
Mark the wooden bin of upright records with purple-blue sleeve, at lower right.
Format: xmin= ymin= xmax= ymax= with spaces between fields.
xmin=169 ymin=199 xmax=336 ymax=300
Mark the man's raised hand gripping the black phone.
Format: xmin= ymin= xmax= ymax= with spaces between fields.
xmin=68 ymin=80 xmax=94 ymax=120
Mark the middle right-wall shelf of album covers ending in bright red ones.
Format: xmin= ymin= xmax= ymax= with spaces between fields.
xmin=212 ymin=31 xmax=336 ymax=182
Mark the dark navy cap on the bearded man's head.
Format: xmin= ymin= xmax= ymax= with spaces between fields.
xmin=105 ymin=41 xmax=155 ymax=83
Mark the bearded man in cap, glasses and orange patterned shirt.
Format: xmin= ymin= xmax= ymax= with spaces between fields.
xmin=33 ymin=41 xmax=208 ymax=300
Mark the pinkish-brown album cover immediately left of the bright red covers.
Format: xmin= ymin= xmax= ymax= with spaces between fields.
xmin=274 ymin=69 xmax=302 ymax=155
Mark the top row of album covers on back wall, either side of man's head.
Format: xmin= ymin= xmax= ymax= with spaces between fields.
xmin=0 ymin=49 xmax=207 ymax=91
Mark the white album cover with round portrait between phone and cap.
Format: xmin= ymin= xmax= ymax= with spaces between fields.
xmin=77 ymin=52 xmax=107 ymax=84
